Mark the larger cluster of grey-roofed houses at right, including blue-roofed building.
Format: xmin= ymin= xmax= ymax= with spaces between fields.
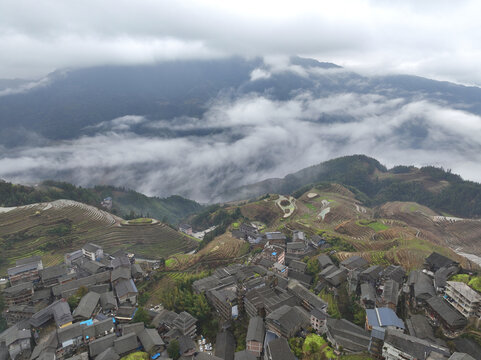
xmin=193 ymin=224 xmax=481 ymax=360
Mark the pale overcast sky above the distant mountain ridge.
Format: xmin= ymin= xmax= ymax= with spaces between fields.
xmin=0 ymin=0 xmax=481 ymax=85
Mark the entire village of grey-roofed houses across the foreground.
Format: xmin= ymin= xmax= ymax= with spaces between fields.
xmin=0 ymin=223 xmax=481 ymax=360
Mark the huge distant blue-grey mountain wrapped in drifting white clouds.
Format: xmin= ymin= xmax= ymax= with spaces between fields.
xmin=0 ymin=57 xmax=481 ymax=201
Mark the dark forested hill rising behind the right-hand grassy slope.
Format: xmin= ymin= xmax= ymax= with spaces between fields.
xmin=222 ymin=155 xmax=481 ymax=218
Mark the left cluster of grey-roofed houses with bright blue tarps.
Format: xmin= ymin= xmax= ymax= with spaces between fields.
xmin=0 ymin=244 xmax=191 ymax=360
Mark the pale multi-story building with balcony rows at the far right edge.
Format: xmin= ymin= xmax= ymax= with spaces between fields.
xmin=445 ymin=281 xmax=481 ymax=318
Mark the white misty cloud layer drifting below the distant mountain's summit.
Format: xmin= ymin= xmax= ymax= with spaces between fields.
xmin=0 ymin=92 xmax=481 ymax=202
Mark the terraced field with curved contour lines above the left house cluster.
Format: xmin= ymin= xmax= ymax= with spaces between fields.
xmin=0 ymin=200 xmax=197 ymax=274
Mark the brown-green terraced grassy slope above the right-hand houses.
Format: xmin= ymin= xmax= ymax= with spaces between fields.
xmin=229 ymin=184 xmax=476 ymax=269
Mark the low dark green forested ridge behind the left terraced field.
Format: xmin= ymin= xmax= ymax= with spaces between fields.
xmin=0 ymin=181 xmax=202 ymax=224
